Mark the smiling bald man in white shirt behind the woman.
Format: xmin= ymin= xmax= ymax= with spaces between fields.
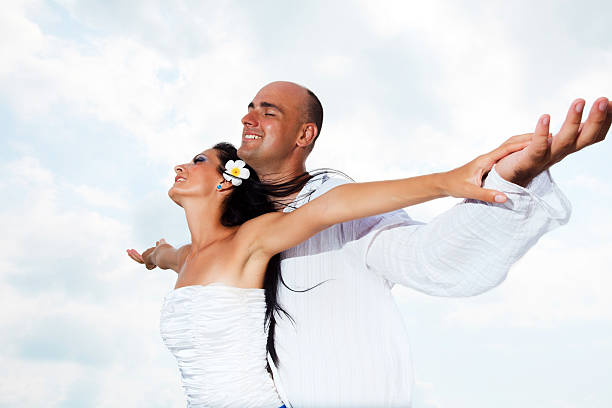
xmin=233 ymin=82 xmax=612 ymax=408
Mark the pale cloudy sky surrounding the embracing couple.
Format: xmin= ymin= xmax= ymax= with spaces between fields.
xmin=0 ymin=0 xmax=612 ymax=408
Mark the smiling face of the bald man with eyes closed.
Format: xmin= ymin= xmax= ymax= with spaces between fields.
xmin=238 ymin=82 xmax=306 ymax=172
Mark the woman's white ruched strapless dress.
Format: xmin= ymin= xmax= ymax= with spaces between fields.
xmin=160 ymin=283 xmax=283 ymax=408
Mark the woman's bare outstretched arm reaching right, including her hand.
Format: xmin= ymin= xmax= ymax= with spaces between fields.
xmin=241 ymin=134 xmax=531 ymax=256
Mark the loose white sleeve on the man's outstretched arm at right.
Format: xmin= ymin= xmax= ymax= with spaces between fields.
xmin=360 ymin=169 xmax=571 ymax=296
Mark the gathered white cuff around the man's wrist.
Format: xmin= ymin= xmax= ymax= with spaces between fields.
xmin=483 ymin=167 xmax=572 ymax=225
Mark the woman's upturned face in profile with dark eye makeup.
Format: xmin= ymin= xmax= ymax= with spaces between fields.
xmin=168 ymin=149 xmax=224 ymax=207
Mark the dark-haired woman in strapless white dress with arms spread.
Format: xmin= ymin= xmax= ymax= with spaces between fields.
xmin=128 ymin=136 xmax=529 ymax=407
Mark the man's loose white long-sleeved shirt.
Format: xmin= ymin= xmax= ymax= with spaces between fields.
xmin=270 ymin=169 xmax=571 ymax=408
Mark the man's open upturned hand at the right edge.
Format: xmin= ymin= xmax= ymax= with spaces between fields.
xmin=495 ymin=98 xmax=612 ymax=187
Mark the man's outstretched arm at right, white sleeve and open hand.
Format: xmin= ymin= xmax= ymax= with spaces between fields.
xmin=365 ymin=98 xmax=612 ymax=296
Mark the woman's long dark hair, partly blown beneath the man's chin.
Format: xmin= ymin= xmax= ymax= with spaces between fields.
xmin=213 ymin=143 xmax=318 ymax=366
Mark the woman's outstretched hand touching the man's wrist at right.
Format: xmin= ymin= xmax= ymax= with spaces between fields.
xmin=442 ymin=133 xmax=533 ymax=203
